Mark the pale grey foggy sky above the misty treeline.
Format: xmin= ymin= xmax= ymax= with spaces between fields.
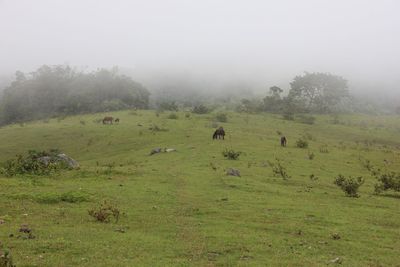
xmin=0 ymin=0 xmax=400 ymax=92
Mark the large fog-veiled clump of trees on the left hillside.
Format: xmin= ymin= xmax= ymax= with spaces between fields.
xmin=0 ymin=65 xmax=150 ymax=124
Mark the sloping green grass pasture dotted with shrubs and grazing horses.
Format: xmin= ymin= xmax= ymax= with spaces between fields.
xmin=0 ymin=111 xmax=400 ymax=266
